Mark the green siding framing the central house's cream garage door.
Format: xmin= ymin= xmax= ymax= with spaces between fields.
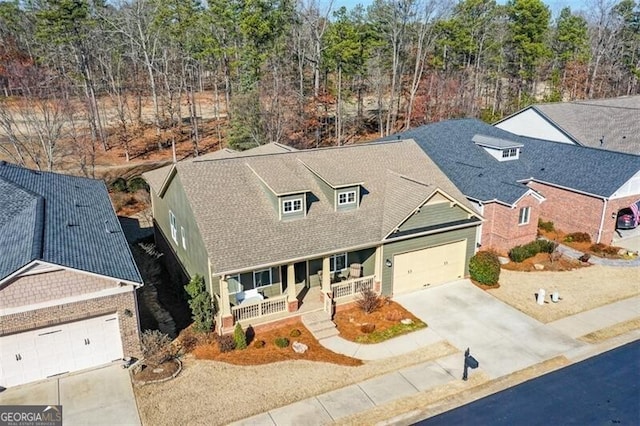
xmin=382 ymin=226 xmax=476 ymax=296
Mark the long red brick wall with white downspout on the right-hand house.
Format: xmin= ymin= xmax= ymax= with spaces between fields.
xmin=529 ymin=182 xmax=640 ymax=244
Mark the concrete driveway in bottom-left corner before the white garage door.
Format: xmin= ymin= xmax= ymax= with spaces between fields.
xmin=0 ymin=364 xmax=140 ymax=426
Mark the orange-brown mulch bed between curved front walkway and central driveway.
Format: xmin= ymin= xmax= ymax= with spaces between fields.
xmin=333 ymin=301 xmax=422 ymax=342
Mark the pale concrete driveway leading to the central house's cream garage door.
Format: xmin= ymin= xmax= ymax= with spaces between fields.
xmin=394 ymin=280 xmax=584 ymax=378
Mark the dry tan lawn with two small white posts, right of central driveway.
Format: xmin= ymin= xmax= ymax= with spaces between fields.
xmin=488 ymin=265 xmax=640 ymax=323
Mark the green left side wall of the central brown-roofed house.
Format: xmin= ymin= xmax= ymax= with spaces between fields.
xmin=152 ymin=175 xmax=211 ymax=288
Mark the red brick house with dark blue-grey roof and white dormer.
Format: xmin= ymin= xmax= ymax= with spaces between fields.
xmin=384 ymin=119 xmax=640 ymax=252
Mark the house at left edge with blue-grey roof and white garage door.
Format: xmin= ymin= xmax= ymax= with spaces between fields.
xmin=0 ymin=162 xmax=142 ymax=387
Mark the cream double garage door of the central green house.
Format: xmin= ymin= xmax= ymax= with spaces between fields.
xmin=393 ymin=240 xmax=467 ymax=294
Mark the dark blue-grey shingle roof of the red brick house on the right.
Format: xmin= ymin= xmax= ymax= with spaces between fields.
xmin=387 ymin=119 xmax=640 ymax=205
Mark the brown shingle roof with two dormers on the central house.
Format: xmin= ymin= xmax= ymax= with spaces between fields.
xmin=145 ymin=141 xmax=472 ymax=273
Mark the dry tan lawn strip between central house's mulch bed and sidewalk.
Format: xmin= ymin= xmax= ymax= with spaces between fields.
xmin=134 ymin=342 xmax=457 ymax=426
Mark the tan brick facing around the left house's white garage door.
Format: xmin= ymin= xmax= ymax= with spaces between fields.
xmin=0 ymin=291 xmax=141 ymax=358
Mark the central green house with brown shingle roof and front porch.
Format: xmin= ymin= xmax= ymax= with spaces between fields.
xmin=144 ymin=141 xmax=482 ymax=331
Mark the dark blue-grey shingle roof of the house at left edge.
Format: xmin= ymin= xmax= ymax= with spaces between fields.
xmin=0 ymin=162 xmax=142 ymax=283
